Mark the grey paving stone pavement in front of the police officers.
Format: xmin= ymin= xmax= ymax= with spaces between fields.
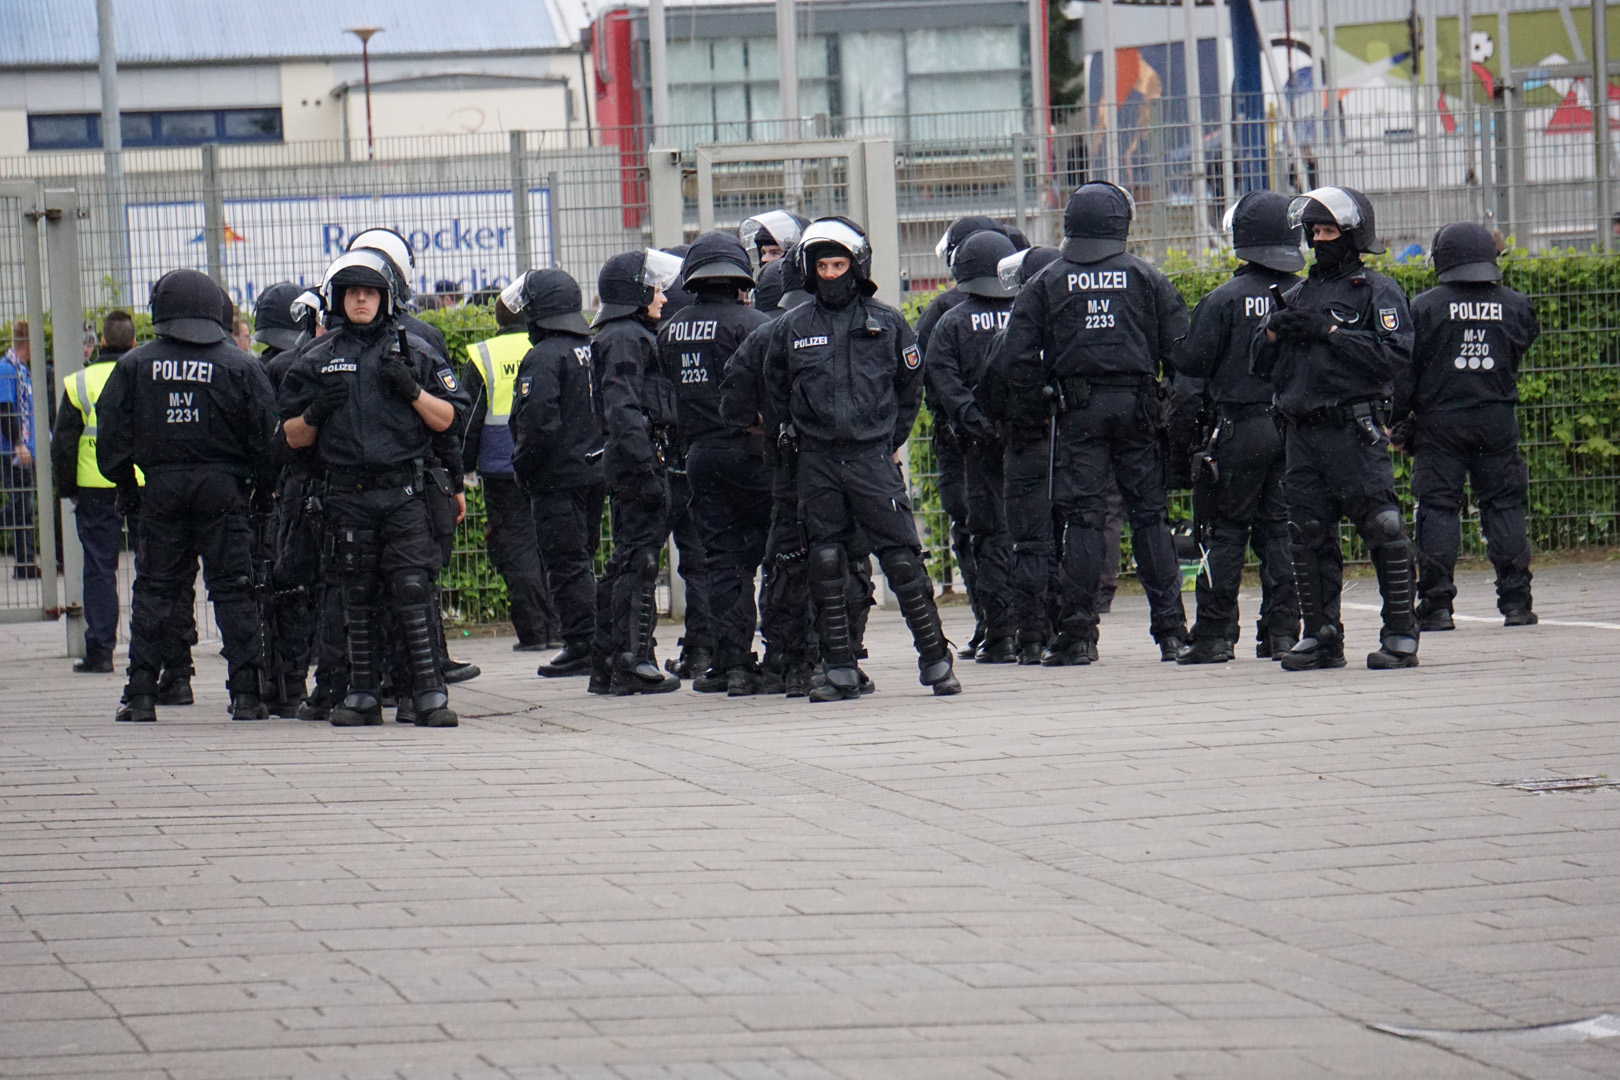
xmin=0 ymin=563 xmax=1620 ymax=1080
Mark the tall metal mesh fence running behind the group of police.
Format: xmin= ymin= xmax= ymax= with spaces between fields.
xmin=0 ymin=95 xmax=1620 ymax=634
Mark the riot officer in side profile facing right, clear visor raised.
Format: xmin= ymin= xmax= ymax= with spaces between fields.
xmin=588 ymin=249 xmax=680 ymax=695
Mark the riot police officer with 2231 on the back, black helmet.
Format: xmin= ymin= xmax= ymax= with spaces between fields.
xmin=96 ymin=270 xmax=275 ymax=722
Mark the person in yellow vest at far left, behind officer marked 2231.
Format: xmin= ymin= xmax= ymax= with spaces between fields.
xmin=50 ymin=311 xmax=134 ymax=675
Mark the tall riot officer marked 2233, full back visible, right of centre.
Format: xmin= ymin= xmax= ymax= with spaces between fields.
xmin=1004 ymin=181 xmax=1187 ymax=667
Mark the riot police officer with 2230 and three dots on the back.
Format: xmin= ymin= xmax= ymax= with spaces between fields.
xmin=1395 ymin=222 xmax=1541 ymax=630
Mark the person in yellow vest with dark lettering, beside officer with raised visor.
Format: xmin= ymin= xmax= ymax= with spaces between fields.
xmin=462 ymin=300 xmax=557 ymax=653
